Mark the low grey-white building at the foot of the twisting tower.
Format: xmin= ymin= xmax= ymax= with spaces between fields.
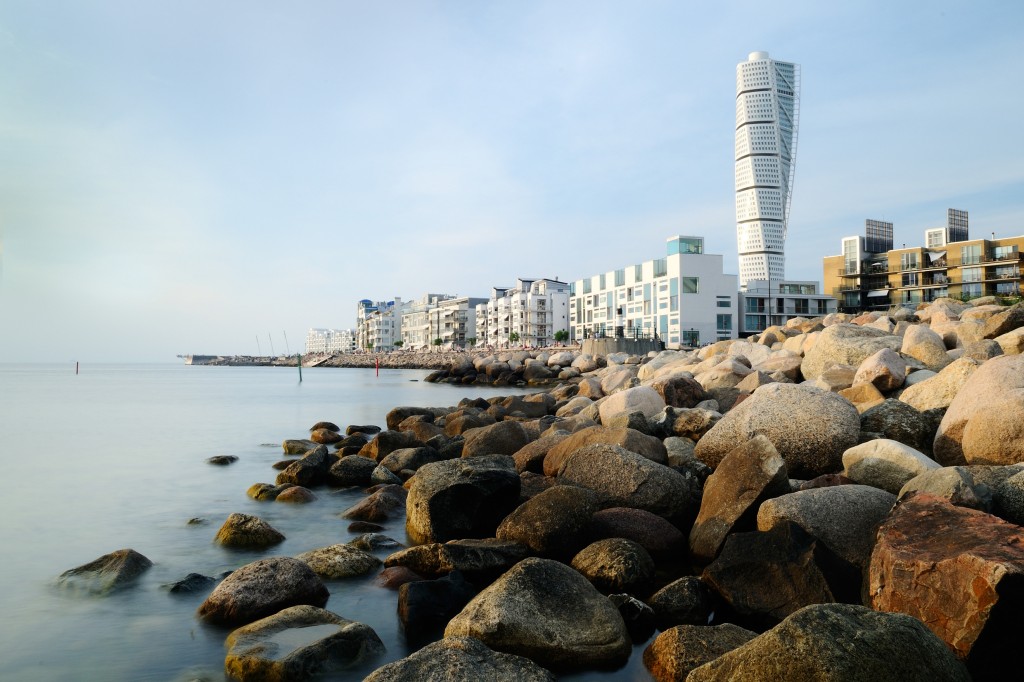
xmin=738 ymin=280 xmax=839 ymax=336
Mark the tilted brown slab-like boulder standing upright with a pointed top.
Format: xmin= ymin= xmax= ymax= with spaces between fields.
xmin=689 ymin=434 xmax=791 ymax=564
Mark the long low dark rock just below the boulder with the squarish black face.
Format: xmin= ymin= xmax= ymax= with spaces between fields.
xmin=384 ymin=538 xmax=526 ymax=583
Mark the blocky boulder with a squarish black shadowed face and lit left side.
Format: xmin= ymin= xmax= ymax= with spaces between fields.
xmin=406 ymin=454 xmax=520 ymax=544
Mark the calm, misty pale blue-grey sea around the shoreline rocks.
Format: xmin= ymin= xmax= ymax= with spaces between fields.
xmin=0 ymin=363 xmax=651 ymax=682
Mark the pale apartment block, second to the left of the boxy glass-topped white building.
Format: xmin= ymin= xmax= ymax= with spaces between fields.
xmin=401 ymin=294 xmax=487 ymax=349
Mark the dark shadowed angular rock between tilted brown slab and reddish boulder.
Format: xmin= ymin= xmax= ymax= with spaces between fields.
xmin=701 ymin=520 xmax=838 ymax=626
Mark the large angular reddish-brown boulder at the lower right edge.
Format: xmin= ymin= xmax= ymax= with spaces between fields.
xmin=870 ymin=493 xmax=1024 ymax=679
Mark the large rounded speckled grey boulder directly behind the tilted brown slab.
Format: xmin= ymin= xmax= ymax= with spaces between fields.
xmin=694 ymin=384 xmax=860 ymax=478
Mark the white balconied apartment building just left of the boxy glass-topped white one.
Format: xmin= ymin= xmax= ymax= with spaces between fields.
xmin=474 ymin=279 xmax=570 ymax=348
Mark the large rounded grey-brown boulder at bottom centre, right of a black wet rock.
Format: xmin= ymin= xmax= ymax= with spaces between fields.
xmin=444 ymin=558 xmax=632 ymax=672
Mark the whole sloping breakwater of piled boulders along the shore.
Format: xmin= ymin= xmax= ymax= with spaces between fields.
xmin=74 ymin=299 xmax=1024 ymax=682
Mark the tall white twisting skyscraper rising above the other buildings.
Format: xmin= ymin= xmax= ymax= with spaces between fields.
xmin=735 ymin=52 xmax=800 ymax=290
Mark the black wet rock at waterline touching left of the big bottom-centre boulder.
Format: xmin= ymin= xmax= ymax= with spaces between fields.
xmin=398 ymin=570 xmax=476 ymax=641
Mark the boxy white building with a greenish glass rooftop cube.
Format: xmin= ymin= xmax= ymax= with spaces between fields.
xmin=569 ymin=236 xmax=736 ymax=348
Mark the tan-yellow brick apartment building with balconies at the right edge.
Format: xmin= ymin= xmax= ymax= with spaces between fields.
xmin=822 ymin=209 xmax=1024 ymax=312
